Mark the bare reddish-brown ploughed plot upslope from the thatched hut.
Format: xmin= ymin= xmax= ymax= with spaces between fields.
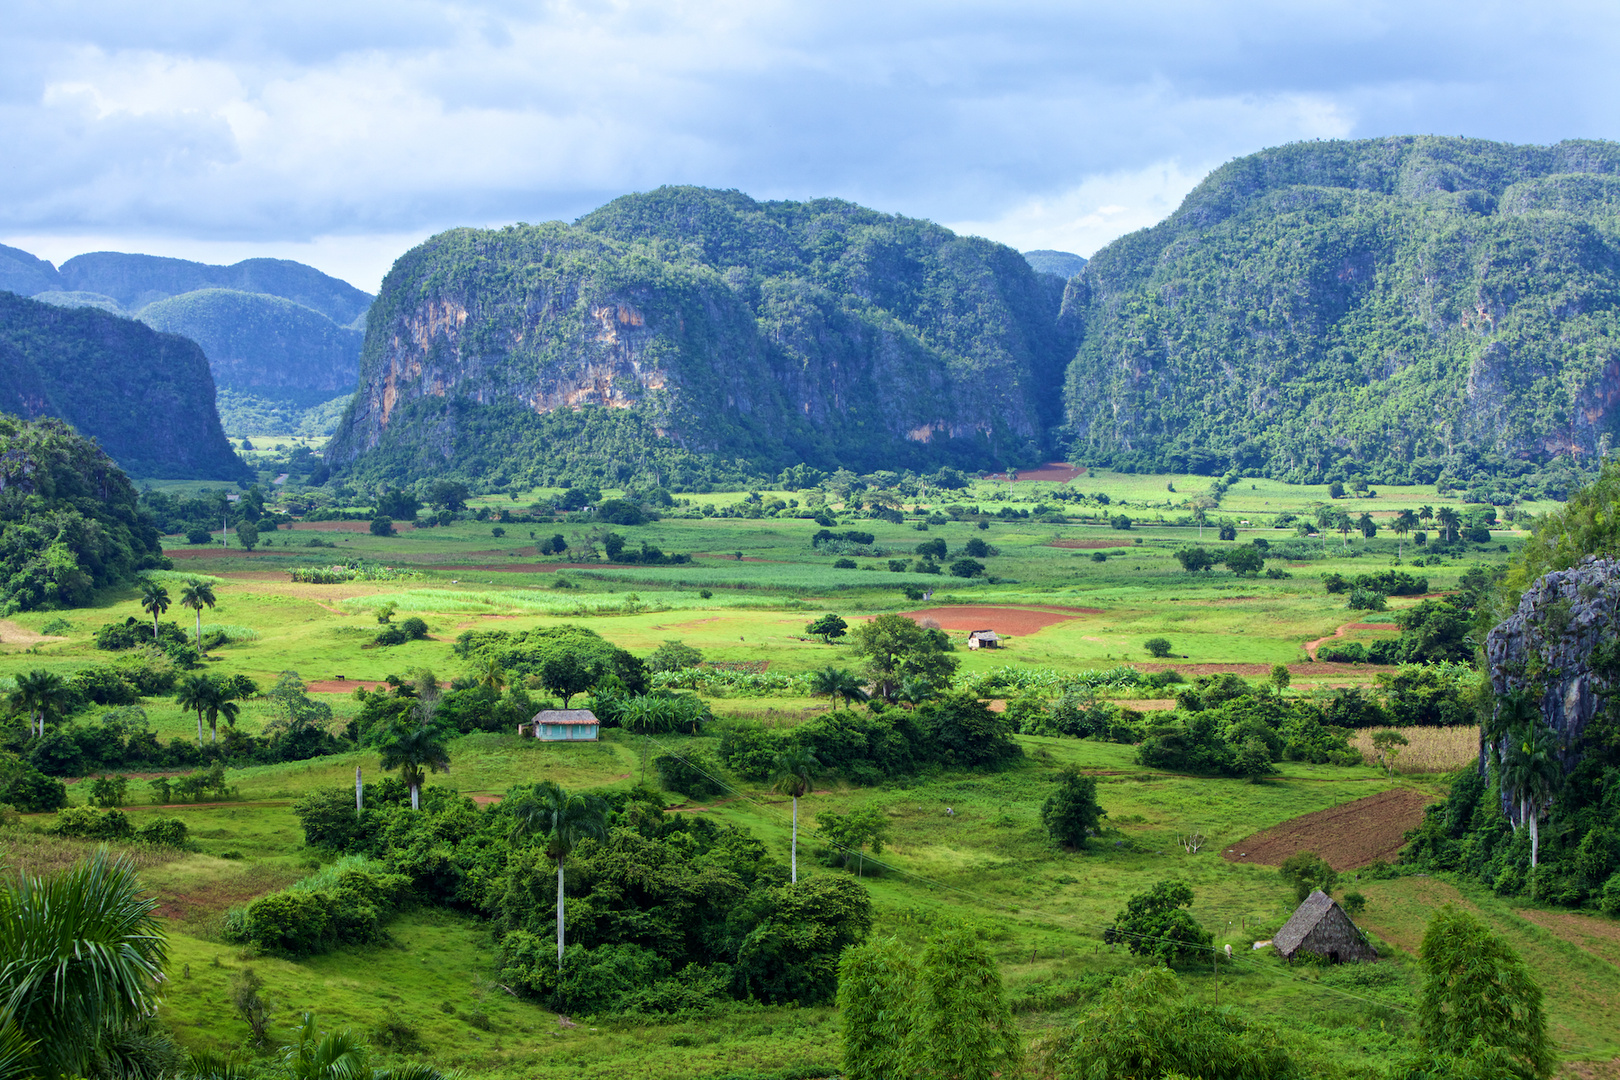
xmin=1221 ymin=787 xmax=1434 ymax=871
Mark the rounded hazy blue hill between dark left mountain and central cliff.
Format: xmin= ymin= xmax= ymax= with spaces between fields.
xmin=136 ymin=288 xmax=365 ymax=408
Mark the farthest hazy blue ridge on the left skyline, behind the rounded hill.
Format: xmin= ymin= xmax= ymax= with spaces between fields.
xmin=58 ymin=251 xmax=371 ymax=327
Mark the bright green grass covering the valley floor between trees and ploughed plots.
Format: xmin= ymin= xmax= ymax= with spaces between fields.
xmin=0 ymin=473 xmax=1620 ymax=1080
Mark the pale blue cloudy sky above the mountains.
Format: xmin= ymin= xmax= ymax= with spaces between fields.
xmin=0 ymin=0 xmax=1620 ymax=291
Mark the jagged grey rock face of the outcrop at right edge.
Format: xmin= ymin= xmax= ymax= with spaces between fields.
xmin=1479 ymin=555 xmax=1620 ymax=772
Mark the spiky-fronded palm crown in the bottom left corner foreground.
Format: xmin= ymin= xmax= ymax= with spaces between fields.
xmin=0 ymin=848 xmax=167 ymax=1077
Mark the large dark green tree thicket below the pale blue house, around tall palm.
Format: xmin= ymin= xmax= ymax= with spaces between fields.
xmin=289 ymin=782 xmax=872 ymax=1015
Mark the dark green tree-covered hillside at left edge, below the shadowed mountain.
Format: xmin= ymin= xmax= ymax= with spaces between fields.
xmin=0 ymin=417 xmax=170 ymax=614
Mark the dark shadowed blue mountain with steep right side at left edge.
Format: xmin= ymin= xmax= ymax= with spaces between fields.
xmin=0 ymin=293 xmax=246 ymax=479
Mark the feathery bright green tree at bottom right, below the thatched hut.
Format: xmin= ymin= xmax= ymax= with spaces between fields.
xmin=1418 ymin=904 xmax=1554 ymax=1080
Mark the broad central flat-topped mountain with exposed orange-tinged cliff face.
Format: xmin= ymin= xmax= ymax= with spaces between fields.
xmin=329 ymin=188 xmax=1074 ymax=483
